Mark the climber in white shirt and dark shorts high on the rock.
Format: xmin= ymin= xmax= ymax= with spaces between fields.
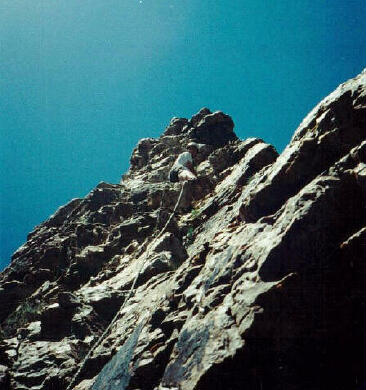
xmin=169 ymin=142 xmax=199 ymax=183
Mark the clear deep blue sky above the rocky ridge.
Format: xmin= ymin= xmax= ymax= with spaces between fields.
xmin=0 ymin=0 xmax=366 ymax=267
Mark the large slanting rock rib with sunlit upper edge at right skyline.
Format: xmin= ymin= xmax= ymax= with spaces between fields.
xmin=241 ymin=72 xmax=366 ymax=221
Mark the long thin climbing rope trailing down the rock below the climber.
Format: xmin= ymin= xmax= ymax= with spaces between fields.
xmin=66 ymin=182 xmax=186 ymax=390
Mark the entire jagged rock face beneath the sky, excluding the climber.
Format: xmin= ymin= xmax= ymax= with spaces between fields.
xmin=0 ymin=72 xmax=366 ymax=390
